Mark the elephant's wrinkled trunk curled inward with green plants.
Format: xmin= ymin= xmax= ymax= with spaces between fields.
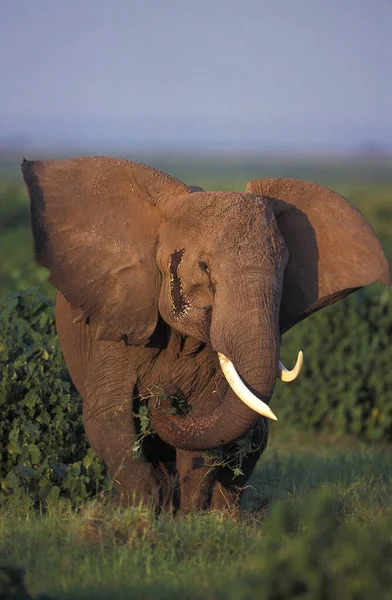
xmin=151 ymin=272 xmax=281 ymax=451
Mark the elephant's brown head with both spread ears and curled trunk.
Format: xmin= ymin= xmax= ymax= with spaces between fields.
xmin=22 ymin=157 xmax=391 ymax=449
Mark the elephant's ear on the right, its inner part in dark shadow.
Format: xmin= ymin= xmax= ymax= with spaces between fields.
xmin=247 ymin=179 xmax=391 ymax=332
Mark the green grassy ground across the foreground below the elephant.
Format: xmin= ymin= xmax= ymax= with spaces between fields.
xmin=0 ymin=426 xmax=392 ymax=600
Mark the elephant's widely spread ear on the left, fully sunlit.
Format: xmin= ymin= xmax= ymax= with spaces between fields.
xmin=22 ymin=157 xmax=190 ymax=344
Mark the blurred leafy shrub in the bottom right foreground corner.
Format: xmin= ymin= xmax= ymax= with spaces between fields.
xmin=224 ymin=493 xmax=392 ymax=600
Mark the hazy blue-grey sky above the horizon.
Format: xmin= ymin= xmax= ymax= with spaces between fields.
xmin=0 ymin=0 xmax=392 ymax=153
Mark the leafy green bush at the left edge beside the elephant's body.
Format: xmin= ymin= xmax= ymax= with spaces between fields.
xmin=0 ymin=292 xmax=107 ymax=505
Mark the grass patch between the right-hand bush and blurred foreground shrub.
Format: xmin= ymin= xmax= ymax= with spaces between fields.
xmin=245 ymin=425 xmax=392 ymax=525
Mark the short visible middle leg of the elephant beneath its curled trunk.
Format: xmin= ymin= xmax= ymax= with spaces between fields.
xmin=177 ymin=449 xmax=216 ymax=514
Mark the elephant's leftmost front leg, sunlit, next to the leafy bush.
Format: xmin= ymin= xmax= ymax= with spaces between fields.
xmin=83 ymin=342 xmax=171 ymax=509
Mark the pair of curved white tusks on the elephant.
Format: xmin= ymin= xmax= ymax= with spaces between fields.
xmin=218 ymin=351 xmax=303 ymax=421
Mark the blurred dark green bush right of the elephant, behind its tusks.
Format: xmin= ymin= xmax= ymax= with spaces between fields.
xmin=272 ymin=289 xmax=392 ymax=440
